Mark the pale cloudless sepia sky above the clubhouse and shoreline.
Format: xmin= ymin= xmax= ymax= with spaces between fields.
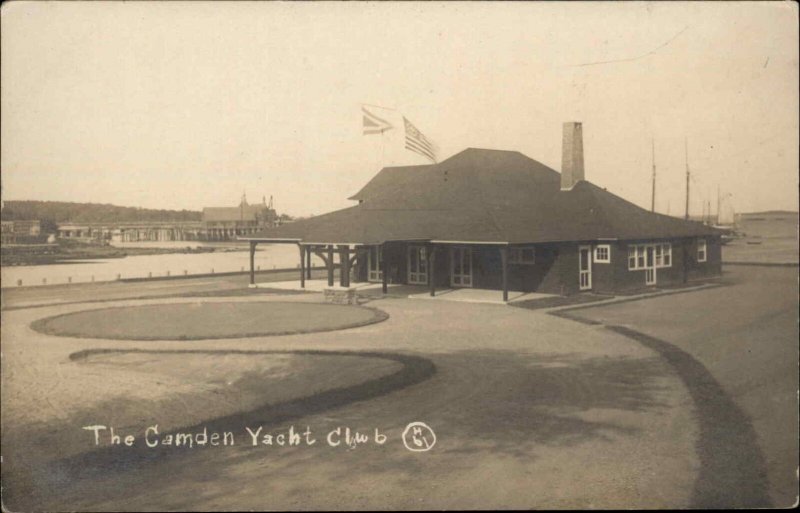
xmin=0 ymin=1 xmax=799 ymax=216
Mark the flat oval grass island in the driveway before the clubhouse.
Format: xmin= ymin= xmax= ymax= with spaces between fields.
xmin=31 ymin=301 xmax=389 ymax=340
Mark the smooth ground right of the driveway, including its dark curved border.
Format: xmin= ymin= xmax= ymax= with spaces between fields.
xmin=560 ymin=266 xmax=800 ymax=508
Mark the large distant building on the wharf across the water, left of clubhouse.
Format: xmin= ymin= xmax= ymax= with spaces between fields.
xmin=203 ymin=195 xmax=280 ymax=240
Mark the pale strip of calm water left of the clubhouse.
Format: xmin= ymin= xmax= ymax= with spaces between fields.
xmin=0 ymin=241 xmax=323 ymax=288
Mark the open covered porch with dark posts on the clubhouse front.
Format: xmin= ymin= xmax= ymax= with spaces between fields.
xmin=248 ymin=239 xmax=564 ymax=303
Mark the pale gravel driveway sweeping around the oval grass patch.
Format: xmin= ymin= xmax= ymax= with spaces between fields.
xmin=2 ymin=295 xmax=701 ymax=510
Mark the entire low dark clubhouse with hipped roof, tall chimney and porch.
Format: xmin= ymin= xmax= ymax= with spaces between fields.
xmin=240 ymin=122 xmax=722 ymax=300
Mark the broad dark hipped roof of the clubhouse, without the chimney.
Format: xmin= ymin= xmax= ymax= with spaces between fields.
xmin=247 ymin=148 xmax=718 ymax=244
